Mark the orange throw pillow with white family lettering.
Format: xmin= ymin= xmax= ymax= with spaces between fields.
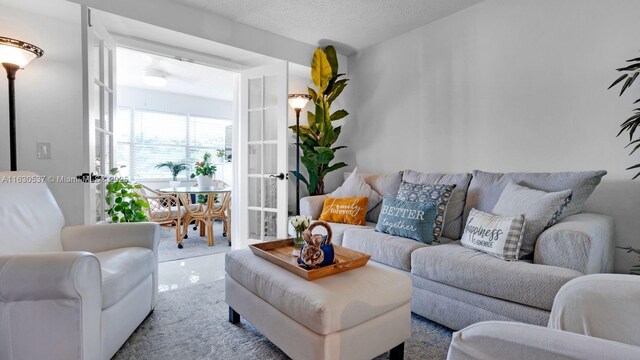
xmin=319 ymin=196 xmax=369 ymax=225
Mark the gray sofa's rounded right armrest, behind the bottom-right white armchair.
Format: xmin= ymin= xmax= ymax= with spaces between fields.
xmin=533 ymin=213 xmax=615 ymax=274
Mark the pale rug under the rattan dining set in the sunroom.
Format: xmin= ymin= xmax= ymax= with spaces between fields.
xmin=158 ymin=221 xmax=231 ymax=262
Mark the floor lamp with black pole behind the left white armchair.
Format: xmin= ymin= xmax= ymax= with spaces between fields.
xmin=0 ymin=36 xmax=44 ymax=171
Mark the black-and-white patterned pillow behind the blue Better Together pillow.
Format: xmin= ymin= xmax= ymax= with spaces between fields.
xmin=397 ymin=181 xmax=456 ymax=241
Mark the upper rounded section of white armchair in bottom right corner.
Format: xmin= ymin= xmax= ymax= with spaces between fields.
xmin=549 ymin=274 xmax=640 ymax=348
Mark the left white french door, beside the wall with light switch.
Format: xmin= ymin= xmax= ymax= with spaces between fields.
xmin=81 ymin=6 xmax=116 ymax=224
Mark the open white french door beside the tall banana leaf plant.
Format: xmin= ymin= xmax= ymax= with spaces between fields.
xmin=233 ymin=62 xmax=288 ymax=247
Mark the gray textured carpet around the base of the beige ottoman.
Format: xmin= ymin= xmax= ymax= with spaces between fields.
xmin=113 ymin=280 xmax=451 ymax=360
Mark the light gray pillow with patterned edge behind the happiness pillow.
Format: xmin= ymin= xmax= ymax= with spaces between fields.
xmin=492 ymin=182 xmax=572 ymax=258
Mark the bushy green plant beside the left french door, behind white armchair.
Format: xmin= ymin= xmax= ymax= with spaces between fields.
xmin=105 ymin=166 xmax=149 ymax=223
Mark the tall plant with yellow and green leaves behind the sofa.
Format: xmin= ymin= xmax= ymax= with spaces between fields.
xmin=289 ymin=46 xmax=349 ymax=195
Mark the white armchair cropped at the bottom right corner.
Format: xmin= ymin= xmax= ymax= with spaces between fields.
xmin=447 ymin=274 xmax=640 ymax=360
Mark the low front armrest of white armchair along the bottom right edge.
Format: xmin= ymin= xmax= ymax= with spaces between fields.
xmin=447 ymin=321 xmax=640 ymax=360
